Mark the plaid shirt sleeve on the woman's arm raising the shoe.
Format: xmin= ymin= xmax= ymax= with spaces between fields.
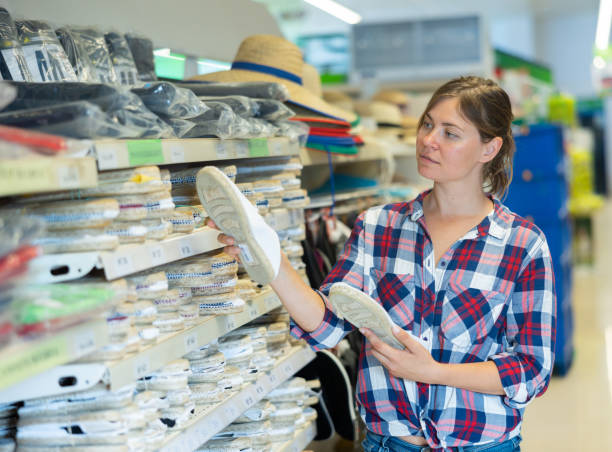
xmin=291 ymin=213 xmax=365 ymax=350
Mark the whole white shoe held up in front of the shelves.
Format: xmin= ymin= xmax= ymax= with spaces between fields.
xmin=196 ymin=166 xmax=281 ymax=284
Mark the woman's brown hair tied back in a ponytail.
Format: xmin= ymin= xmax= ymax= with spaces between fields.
xmin=418 ymin=76 xmax=514 ymax=198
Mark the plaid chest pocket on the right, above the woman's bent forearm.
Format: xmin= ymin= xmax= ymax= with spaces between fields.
xmin=440 ymin=284 xmax=506 ymax=350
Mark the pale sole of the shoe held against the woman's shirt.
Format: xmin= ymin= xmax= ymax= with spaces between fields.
xmin=328 ymin=283 xmax=405 ymax=349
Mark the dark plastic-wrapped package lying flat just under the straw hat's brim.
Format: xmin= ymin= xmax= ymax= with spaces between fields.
xmin=178 ymin=80 xmax=289 ymax=102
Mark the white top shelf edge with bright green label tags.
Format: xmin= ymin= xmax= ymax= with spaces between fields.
xmin=94 ymin=137 xmax=299 ymax=170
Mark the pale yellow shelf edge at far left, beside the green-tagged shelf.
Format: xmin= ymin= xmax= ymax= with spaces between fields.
xmin=0 ymin=156 xmax=98 ymax=196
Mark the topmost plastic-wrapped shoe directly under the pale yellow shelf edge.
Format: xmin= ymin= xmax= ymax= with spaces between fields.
xmin=13 ymin=198 xmax=119 ymax=231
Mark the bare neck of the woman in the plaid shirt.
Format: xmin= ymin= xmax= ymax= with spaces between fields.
xmin=423 ymin=183 xmax=493 ymax=219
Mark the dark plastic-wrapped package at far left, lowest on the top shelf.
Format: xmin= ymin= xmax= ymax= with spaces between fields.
xmin=0 ymin=101 xmax=142 ymax=138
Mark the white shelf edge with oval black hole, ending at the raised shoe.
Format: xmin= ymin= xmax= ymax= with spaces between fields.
xmin=28 ymin=227 xmax=223 ymax=283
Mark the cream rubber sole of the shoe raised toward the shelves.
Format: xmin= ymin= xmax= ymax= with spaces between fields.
xmin=196 ymin=166 xmax=276 ymax=285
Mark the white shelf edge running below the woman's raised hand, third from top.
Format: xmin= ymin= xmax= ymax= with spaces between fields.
xmin=105 ymin=289 xmax=281 ymax=391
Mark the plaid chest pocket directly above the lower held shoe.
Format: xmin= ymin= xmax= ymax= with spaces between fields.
xmin=369 ymin=267 xmax=415 ymax=329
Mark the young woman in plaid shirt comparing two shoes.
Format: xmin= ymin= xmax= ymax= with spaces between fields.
xmin=212 ymin=77 xmax=555 ymax=452
